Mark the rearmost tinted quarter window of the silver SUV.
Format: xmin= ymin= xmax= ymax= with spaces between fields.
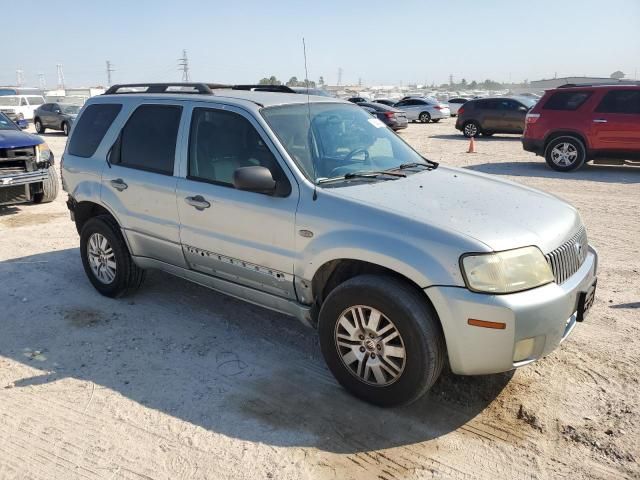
xmin=69 ymin=103 xmax=122 ymax=158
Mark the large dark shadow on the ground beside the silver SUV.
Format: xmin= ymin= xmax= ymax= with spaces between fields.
xmin=0 ymin=249 xmax=513 ymax=453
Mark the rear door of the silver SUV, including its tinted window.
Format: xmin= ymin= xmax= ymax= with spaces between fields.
xmin=102 ymin=100 xmax=185 ymax=266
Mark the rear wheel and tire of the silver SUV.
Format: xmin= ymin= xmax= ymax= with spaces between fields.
xmin=80 ymin=215 xmax=145 ymax=298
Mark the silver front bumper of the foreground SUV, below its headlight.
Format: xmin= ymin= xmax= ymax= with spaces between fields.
xmin=425 ymin=247 xmax=598 ymax=375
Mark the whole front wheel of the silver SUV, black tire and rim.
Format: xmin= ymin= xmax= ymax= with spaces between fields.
xmin=318 ymin=275 xmax=445 ymax=406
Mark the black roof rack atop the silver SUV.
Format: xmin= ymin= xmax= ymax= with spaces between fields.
xmin=104 ymin=83 xmax=296 ymax=95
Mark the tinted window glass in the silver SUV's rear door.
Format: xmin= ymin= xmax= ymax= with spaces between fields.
xmin=118 ymin=105 xmax=182 ymax=175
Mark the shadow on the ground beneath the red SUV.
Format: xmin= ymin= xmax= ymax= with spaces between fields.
xmin=463 ymin=158 xmax=640 ymax=184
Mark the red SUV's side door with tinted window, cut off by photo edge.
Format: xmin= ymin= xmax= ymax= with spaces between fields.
xmin=591 ymin=88 xmax=640 ymax=157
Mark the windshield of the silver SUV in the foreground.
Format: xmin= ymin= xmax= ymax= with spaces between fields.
xmin=262 ymin=103 xmax=426 ymax=182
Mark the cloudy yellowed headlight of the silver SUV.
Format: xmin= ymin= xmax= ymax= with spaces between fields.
xmin=461 ymin=247 xmax=554 ymax=293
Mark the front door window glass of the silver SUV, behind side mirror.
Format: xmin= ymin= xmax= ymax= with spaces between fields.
xmin=188 ymin=108 xmax=288 ymax=193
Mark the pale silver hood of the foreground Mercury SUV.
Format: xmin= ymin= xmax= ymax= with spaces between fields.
xmin=331 ymin=166 xmax=582 ymax=253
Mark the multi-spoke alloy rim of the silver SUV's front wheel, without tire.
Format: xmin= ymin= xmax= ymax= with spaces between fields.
xmin=334 ymin=305 xmax=406 ymax=387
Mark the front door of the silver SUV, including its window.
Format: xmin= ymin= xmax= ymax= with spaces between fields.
xmin=177 ymin=103 xmax=298 ymax=298
